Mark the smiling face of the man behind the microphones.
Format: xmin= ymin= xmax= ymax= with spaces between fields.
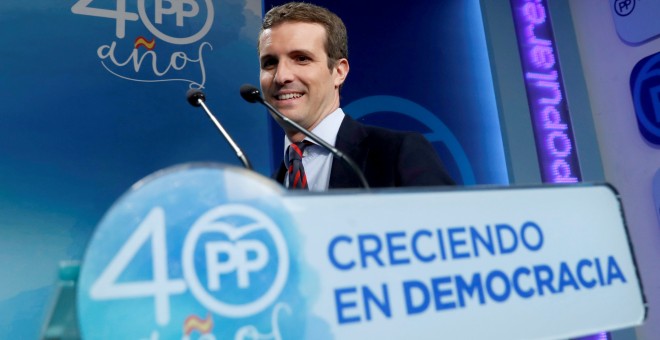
xmin=259 ymin=22 xmax=348 ymax=139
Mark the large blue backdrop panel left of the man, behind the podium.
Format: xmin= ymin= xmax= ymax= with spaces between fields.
xmin=0 ymin=0 xmax=270 ymax=339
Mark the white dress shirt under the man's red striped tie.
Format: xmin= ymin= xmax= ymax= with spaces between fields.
xmin=284 ymin=108 xmax=345 ymax=191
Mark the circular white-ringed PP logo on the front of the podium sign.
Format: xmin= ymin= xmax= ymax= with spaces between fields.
xmin=182 ymin=205 xmax=289 ymax=317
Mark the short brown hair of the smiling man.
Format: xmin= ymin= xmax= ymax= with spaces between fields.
xmin=257 ymin=2 xmax=348 ymax=69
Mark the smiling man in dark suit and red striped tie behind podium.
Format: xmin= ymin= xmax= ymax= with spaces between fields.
xmin=258 ymin=3 xmax=454 ymax=190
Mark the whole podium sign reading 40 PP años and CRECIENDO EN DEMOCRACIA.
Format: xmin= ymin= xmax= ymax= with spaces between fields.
xmin=78 ymin=165 xmax=646 ymax=339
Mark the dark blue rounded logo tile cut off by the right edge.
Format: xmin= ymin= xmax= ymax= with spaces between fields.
xmin=630 ymin=53 xmax=660 ymax=145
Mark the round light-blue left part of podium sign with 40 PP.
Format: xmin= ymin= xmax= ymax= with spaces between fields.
xmin=78 ymin=166 xmax=316 ymax=339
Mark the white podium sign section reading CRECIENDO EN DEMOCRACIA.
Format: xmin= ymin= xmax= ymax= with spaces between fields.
xmin=287 ymin=186 xmax=645 ymax=339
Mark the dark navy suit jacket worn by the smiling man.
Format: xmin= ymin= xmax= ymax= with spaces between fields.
xmin=273 ymin=115 xmax=454 ymax=189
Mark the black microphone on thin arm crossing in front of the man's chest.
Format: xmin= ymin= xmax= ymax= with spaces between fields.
xmin=241 ymin=84 xmax=369 ymax=189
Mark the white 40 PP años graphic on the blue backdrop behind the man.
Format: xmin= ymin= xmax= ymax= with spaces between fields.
xmin=71 ymin=0 xmax=214 ymax=89
